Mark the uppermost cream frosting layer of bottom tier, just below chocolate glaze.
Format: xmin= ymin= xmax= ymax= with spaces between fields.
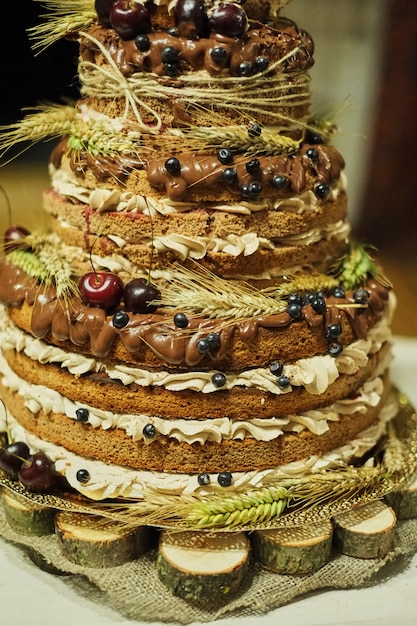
xmin=0 ymin=298 xmax=394 ymax=395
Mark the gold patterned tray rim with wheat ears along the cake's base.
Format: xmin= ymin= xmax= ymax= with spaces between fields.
xmin=0 ymin=392 xmax=417 ymax=531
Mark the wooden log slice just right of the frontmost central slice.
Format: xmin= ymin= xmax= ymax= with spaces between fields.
xmin=250 ymin=521 xmax=333 ymax=574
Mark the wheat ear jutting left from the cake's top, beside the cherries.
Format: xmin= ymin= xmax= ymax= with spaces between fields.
xmin=28 ymin=0 xmax=97 ymax=54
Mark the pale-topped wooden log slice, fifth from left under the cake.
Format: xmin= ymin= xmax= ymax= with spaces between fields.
xmin=333 ymin=500 xmax=397 ymax=559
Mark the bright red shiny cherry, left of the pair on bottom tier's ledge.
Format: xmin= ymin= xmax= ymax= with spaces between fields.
xmin=78 ymin=272 xmax=123 ymax=311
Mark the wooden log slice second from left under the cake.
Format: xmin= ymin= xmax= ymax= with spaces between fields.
xmin=55 ymin=511 xmax=148 ymax=568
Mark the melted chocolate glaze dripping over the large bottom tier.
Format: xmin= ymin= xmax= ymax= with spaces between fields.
xmin=0 ymin=259 xmax=388 ymax=367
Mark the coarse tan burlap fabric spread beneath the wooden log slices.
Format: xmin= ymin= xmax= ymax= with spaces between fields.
xmin=0 ymin=506 xmax=417 ymax=624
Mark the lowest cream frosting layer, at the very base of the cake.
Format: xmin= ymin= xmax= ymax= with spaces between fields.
xmin=0 ymin=396 xmax=398 ymax=500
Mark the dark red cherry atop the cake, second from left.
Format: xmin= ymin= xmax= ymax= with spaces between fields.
xmin=110 ymin=0 xmax=152 ymax=40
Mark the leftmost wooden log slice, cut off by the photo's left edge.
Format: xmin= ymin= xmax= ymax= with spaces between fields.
xmin=1 ymin=489 xmax=56 ymax=537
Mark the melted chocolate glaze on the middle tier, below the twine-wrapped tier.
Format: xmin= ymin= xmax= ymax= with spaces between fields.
xmin=51 ymin=139 xmax=345 ymax=201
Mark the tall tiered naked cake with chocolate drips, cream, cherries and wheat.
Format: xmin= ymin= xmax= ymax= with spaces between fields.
xmin=0 ymin=0 xmax=412 ymax=604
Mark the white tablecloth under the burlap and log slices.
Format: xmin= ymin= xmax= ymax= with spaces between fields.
xmin=0 ymin=337 xmax=417 ymax=626
